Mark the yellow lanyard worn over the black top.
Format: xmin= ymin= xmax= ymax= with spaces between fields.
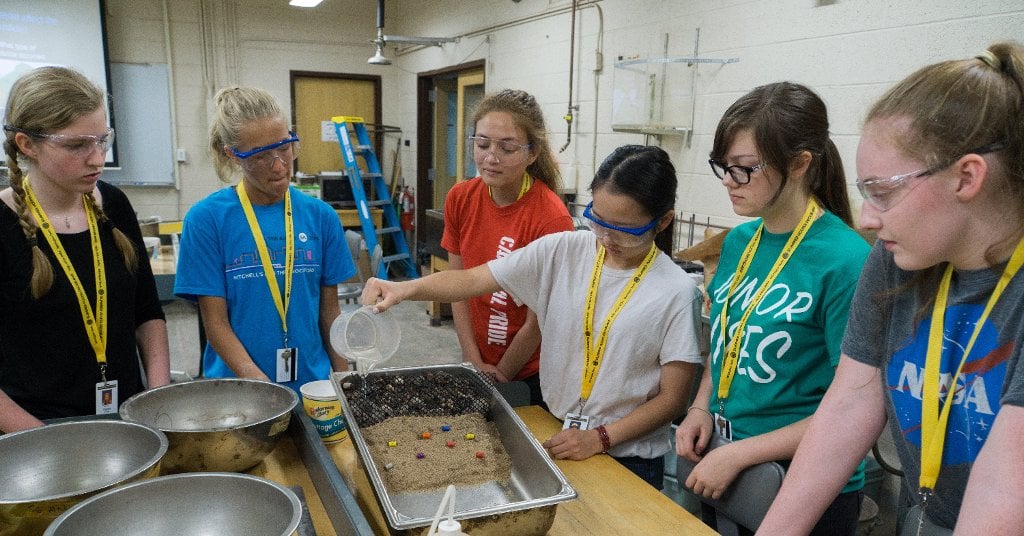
xmin=25 ymin=180 xmax=106 ymax=383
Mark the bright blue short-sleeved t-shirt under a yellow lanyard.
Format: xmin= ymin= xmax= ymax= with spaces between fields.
xmin=174 ymin=187 xmax=355 ymax=390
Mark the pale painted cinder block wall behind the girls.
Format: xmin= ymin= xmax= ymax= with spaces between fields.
xmin=106 ymin=0 xmax=1024 ymax=232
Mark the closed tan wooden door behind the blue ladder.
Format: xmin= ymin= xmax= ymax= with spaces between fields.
xmin=291 ymin=71 xmax=383 ymax=175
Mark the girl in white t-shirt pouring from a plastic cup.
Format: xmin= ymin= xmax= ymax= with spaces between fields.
xmin=362 ymin=146 xmax=700 ymax=489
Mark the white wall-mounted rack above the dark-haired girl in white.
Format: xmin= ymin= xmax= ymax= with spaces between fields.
xmin=611 ymin=56 xmax=739 ymax=147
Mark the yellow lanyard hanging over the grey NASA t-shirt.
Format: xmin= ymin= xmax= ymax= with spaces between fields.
xmin=920 ymin=239 xmax=1024 ymax=493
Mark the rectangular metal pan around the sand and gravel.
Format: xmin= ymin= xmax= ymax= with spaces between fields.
xmin=331 ymin=364 xmax=577 ymax=536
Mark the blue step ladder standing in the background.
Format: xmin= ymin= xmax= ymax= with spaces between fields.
xmin=331 ymin=116 xmax=420 ymax=280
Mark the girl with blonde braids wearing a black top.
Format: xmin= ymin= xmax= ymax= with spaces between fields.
xmin=0 ymin=67 xmax=170 ymax=432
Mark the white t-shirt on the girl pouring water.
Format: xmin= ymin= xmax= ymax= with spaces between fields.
xmin=487 ymin=231 xmax=702 ymax=458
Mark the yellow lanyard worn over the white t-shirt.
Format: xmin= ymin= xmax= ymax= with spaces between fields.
xmin=580 ymin=244 xmax=657 ymax=401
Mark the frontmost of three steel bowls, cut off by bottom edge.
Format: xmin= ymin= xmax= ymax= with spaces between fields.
xmin=45 ymin=472 xmax=302 ymax=536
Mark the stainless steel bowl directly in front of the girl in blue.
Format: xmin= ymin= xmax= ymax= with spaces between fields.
xmin=121 ymin=378 xmax=299 ymax=473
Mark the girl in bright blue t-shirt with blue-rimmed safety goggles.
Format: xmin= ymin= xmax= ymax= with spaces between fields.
xmin=174 ymin=87 xmax=355 ymax=390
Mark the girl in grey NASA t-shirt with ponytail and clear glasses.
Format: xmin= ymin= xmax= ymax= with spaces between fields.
xmin=761 ymin=42 xmax=1024 ymax=535
